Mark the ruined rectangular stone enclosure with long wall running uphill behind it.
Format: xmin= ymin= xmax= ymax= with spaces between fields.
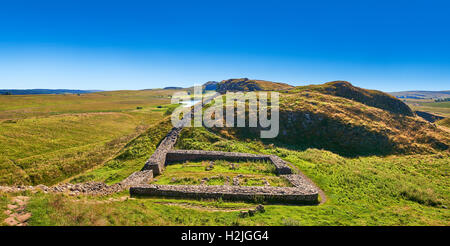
xmin=130 ymin=95 xmax=319 ymax=204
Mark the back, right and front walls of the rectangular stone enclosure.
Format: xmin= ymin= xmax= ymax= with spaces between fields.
xmin=130 ymin=150 xmax=318 ymax=204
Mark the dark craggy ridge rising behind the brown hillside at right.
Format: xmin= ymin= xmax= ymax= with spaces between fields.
xmin=292 ymin=81 xmax=414 ymax=116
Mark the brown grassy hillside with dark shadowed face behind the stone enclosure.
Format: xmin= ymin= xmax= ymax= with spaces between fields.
xmin=209 ymin=90 xmax=450 ymax=156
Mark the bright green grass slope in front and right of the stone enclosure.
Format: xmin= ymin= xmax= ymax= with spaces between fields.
xmin=6 ymin=126 xmax=450 ymax=226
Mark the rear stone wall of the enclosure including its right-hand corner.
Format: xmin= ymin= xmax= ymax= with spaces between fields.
xmin=166 ymin=150 xmax=292 ymax=175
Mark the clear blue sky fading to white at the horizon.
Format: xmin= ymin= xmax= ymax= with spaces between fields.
xmin=0 ymin=0 xmax=450 ymax=91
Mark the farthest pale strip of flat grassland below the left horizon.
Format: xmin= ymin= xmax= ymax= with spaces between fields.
xmin=0 ymin=90 xmax=174 ymax=120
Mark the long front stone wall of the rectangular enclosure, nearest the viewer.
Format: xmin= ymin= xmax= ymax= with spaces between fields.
xmin=130 ymin=185 xmax=318 ymax=204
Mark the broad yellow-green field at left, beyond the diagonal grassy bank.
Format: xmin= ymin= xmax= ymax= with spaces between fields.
xmin=0 ymin=90 xmax=179 ymax=184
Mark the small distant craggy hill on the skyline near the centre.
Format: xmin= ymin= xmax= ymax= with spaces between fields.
xmin=216 ymin=78 xmax=294 ymax=93
